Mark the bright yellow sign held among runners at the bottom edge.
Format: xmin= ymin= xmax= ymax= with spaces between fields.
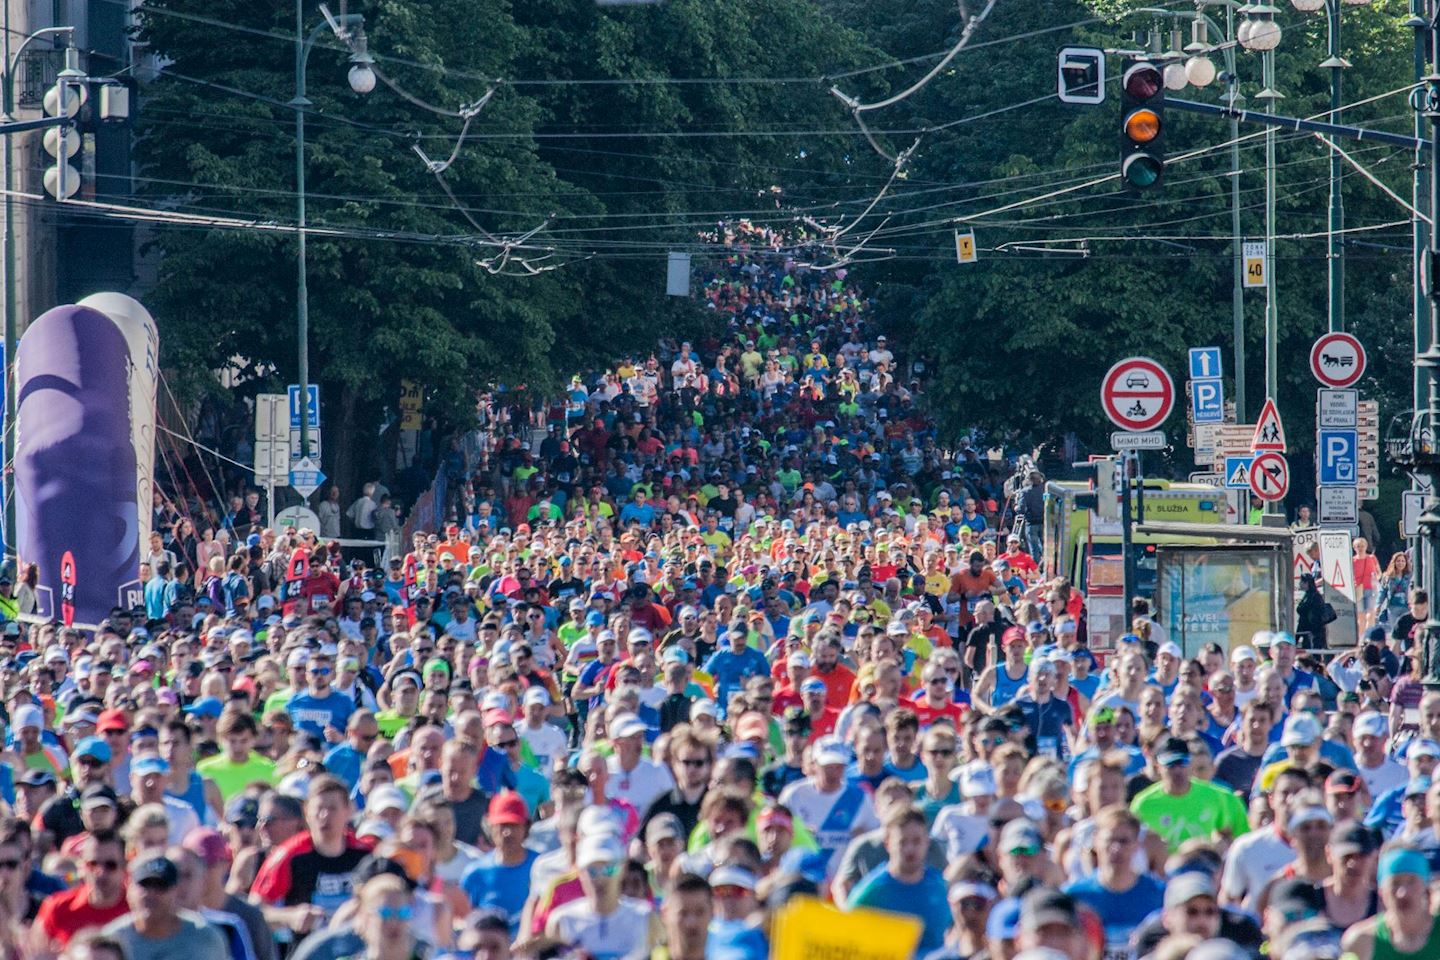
xmin=770 ymin=897 xmax=920 ymax=960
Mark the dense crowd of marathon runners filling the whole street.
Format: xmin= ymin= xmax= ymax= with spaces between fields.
xmin=0 ymin=223 xmax=1440 ymax=960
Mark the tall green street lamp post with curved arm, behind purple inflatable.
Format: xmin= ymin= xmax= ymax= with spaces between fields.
xmin=289 ymin=0 xmax=376 ymax=458
